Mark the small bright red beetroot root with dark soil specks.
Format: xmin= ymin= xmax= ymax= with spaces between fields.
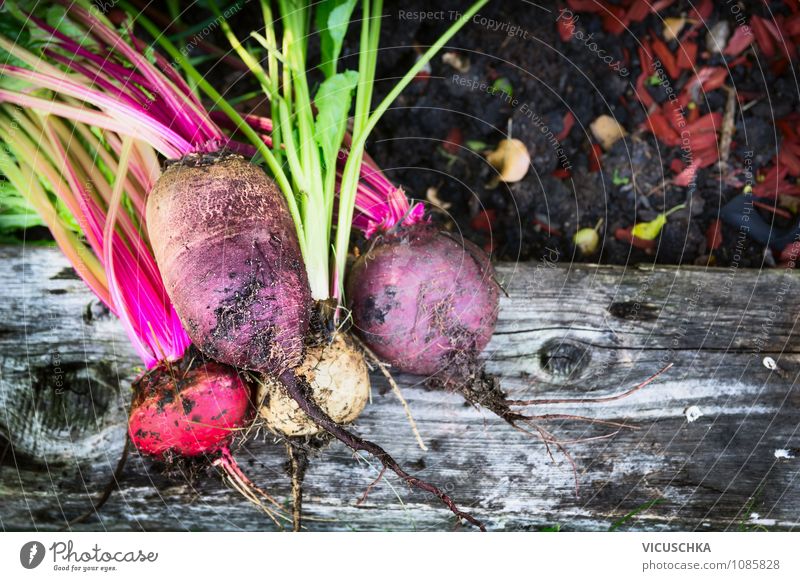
xmin=128 ymin=363 xmax=251 ymax=458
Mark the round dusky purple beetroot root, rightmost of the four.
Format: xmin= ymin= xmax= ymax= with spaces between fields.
xmin=347 ymin=225 xmax=499 ymax=375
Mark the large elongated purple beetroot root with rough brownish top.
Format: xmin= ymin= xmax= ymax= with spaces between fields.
xmin=147 ymin=154 xmax=311 ymax=374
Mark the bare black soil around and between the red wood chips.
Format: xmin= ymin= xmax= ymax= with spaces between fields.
xmin=340 ymin=1 xmax=798 ymax=267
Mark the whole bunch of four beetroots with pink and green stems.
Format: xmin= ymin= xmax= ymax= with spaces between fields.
xmin=0 ymin=0 xmax=672 ymax=529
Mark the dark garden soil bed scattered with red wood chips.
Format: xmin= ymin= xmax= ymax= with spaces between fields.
xmin=356 ymin=1 xmax=800 ymax=267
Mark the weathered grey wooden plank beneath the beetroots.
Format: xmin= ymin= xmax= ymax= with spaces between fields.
xmin=0 ymin=248 xmax=800 ymax=530
